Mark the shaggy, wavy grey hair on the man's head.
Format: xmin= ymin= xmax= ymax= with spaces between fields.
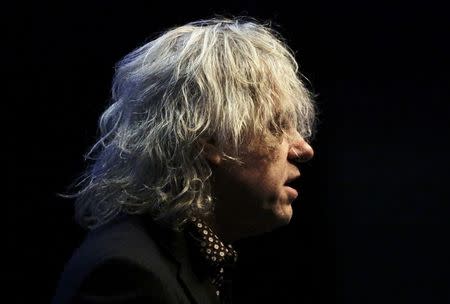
xmin=74 ymin=19 xmax=315 ymax=229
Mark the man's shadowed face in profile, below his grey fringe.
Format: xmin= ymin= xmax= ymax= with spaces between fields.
xmin=212 ymin=131 xmax=314 ymax=240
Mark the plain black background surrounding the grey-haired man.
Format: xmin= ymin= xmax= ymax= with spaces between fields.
xmin=7 ymin=1 xmax=450 ymax=304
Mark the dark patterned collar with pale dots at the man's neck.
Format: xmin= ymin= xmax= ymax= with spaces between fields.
xmin=186 ymin=217 xmax=237 ymax=303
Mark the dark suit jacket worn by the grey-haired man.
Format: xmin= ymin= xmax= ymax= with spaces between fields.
xmin=52 ymin=216 xmax=219 ymax=304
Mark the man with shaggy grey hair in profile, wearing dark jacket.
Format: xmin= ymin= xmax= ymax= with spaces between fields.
xmin=53 ymin=19 xmax=314 ymax=304
